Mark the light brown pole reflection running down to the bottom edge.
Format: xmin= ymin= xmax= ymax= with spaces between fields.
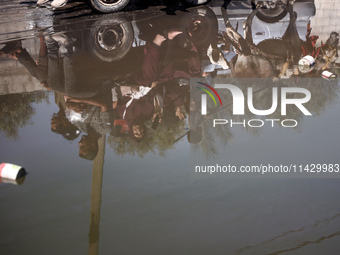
xmin=89 ymin=136 xmax=105 ymax=255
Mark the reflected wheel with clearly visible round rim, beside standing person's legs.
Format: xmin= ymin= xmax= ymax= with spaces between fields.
xmin=89 ymin=16 xmax=134 ymax=62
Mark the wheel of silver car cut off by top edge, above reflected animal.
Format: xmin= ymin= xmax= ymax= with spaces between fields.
xmin=253 ymin=0 xmax=288 ymax=23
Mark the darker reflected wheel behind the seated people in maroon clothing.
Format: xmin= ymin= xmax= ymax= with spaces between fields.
xmin=181 ymin=7 xmax=218 ymax=48
